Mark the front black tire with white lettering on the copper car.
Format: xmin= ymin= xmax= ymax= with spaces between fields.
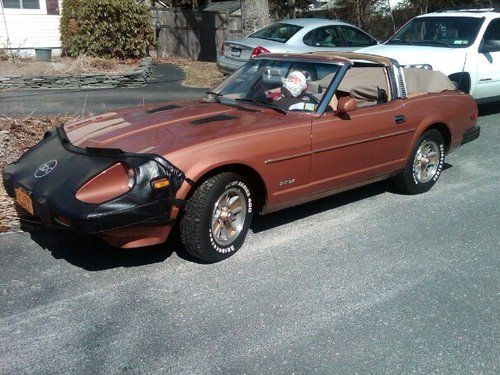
xmin=180 ymin=172 xmax=253 ymax=262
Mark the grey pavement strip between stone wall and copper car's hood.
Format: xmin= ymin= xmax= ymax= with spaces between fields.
xmin=0 ymin=64 xmax=207 ymax=116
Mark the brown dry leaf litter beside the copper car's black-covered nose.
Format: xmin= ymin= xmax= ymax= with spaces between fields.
xmin=0 ymin=116 xmax=75 ymax=232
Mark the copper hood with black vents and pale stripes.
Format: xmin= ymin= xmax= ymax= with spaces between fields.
xmin=64 ymin=100 xmax=294 ymax=157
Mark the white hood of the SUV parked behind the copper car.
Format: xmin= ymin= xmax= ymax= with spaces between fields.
xmin=356 ymin=44 xmax=467 ymax=75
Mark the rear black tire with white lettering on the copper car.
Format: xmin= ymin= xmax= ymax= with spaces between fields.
xmin=393 ymin=129 xmax=445 ymax=194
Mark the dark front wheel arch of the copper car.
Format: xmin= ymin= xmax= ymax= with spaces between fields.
xmin=185 ymin=163 xmax=268 ymax=212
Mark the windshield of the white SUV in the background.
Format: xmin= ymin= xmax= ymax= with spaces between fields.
xmin=387 ymin=17 xmax=483 ymax=48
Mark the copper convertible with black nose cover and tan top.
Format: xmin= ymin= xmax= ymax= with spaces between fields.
xmin=3 ymin=52 xmax=480 ymax=261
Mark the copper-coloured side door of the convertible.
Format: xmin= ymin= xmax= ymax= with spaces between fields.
xmin=310 ymin=100 xmax=411 ymax=195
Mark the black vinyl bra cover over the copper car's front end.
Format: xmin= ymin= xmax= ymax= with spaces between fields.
xmin=3 ymin=127 xmax=184 ymax=234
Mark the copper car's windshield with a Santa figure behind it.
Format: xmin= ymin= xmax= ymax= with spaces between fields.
xmin=209 ymin=58 xmax=341 ymax=112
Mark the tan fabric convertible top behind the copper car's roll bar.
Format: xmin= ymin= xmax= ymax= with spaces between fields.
xmin=403 ymin=68 xmax=455 ymax=95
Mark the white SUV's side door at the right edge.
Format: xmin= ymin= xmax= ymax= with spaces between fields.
xmin=474 ymin=18 xmax=500 ymax=99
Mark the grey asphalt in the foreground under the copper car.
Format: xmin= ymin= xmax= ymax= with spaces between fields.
xmin=0 ymin=105 xmax=500 ymax=374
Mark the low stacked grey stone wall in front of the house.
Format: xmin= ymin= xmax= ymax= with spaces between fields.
xmin=0 ymin=57 xmax=153 ymax=89
